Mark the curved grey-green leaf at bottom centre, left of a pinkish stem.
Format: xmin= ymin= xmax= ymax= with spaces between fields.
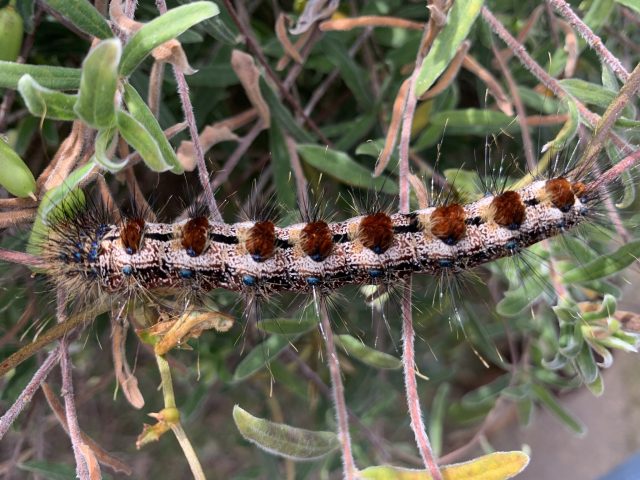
xmin=233 ymin=405 xmax=340 ymax=460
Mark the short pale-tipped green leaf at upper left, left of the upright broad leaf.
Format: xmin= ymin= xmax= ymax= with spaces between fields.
xmin=18 ymin=75 xmax=78 ymax=120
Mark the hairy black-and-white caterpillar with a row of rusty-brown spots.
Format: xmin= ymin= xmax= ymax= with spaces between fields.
xmin=44 ymin=177 xmax=595 ymax=296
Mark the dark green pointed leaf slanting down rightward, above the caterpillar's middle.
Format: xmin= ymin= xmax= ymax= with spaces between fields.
xmin=298 ymin=144 xmax=398 ymax=195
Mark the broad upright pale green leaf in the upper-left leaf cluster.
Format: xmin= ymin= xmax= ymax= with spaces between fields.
xmin=74 ymin=38 xmax=122 ymax=128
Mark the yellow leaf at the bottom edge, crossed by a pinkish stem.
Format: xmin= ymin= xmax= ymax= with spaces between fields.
xmin=360 ymin=452 xmax=529 ymax=480
